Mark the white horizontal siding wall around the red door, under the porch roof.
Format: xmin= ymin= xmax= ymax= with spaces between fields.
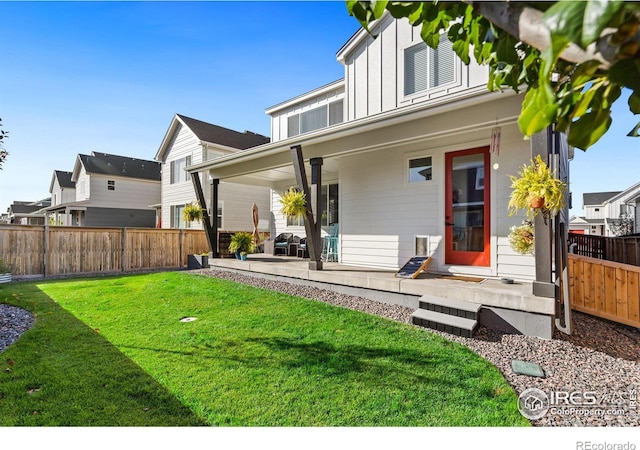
xmin=339 ymin=112 xmax=535 ymax=279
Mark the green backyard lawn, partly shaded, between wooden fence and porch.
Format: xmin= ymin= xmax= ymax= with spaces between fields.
xmin=0 ymin=273 xmax=528 ymax=426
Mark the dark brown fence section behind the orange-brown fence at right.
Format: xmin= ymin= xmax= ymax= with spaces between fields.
xmin=569 ymin=233 xmax=640 ymax=266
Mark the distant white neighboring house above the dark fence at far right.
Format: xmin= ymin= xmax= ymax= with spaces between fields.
xmin=569 ymin=183 xmax=640 ymax=236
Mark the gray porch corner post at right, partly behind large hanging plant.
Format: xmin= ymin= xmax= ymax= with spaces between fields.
xmin=531 ymin=127 xmax=555 ymax=298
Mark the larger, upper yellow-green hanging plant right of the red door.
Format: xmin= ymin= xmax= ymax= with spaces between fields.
xmin=508 ymin=155 xmax=567 ymax=219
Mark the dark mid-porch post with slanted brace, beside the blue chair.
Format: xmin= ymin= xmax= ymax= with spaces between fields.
xmin=291 ymin=145 xmax=322 ymax=270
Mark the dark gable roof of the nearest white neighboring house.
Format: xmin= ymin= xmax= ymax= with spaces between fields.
xmin=155 ymin=114 xmax=271 ymax=161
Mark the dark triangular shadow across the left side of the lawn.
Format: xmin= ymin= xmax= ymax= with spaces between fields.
xmin=0 ymin=283 xmax=205 ymax=426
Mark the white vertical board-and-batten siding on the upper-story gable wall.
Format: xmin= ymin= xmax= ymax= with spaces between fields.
xmin=344 ymin=15 xmax=488 ymax=120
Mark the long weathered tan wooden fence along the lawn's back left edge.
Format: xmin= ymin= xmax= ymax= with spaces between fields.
xmin=0 ymin=225 xmax=209 ymax=276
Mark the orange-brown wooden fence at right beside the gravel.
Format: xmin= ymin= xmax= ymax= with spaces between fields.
xmin=568 ymin=254 xmax=640 ymax=328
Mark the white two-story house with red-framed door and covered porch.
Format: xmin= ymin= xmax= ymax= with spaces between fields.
xmin=188 ymin=14 xmax=569 ymax=338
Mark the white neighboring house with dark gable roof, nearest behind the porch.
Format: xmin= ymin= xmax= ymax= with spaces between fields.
xmin=155 ymin=114 xmax=271 ymax=231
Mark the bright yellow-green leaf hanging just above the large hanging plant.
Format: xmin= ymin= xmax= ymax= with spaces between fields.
xmin=518 ymin=86 xmax=558 ymax=136
